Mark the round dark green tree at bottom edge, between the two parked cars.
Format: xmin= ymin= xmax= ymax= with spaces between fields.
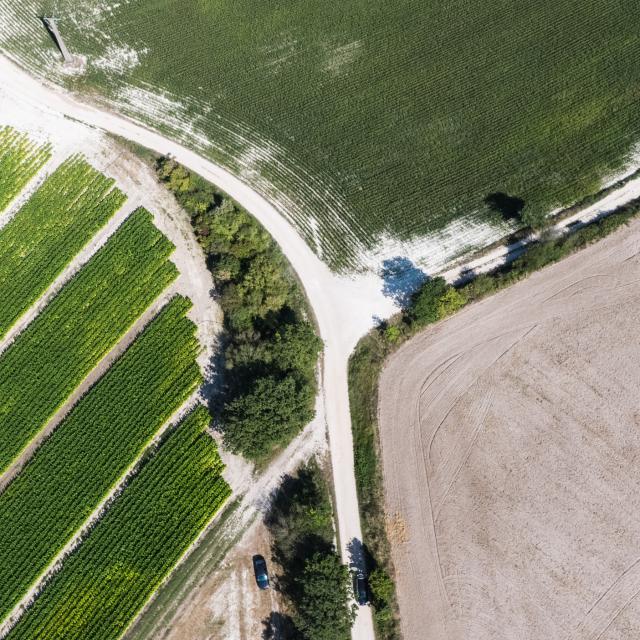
xmin=293 ymin=551 xmax=357 ymax=640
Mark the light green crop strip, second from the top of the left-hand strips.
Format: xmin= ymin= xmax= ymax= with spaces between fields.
xmin=0 ymin=156 xmax=125 ymax=336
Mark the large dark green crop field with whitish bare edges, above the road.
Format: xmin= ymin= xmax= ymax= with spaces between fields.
xmin=0 ymin=0 xmax=640 ymax=266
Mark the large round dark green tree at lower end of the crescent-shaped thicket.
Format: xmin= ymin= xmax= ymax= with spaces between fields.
xmin=223 ymin=376 xmax=313 ymax=459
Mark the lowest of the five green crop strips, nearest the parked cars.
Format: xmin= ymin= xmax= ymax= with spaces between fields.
xmin=8 ymin=406 xmax=230 ymax=640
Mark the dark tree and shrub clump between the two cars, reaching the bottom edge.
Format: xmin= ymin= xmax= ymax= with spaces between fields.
xmin=264 ymin=462 xmax=356 ymax=640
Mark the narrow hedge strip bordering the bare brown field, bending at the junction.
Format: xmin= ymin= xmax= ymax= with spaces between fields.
xmin=349 ymin=199 xmax=640 ymax=640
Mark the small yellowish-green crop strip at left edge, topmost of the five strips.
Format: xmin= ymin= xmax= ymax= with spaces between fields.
xmin=0 ymin=127 xmax=51 ymax=211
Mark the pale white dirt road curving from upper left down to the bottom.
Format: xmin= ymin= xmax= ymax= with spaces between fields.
xmin=0 ymin=55 xmax=380 ymax=640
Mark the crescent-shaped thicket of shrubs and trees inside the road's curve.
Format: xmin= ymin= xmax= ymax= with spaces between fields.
xmin=155 ymin=157 xmax=322 ymax=464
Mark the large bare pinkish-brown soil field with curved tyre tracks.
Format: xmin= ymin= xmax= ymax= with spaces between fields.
xmin=378 ymin=222 xmax=640 ymax=640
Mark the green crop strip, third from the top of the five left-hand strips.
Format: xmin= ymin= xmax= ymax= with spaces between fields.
xmin=0 ymin=210 xmax=177 ymax=472
